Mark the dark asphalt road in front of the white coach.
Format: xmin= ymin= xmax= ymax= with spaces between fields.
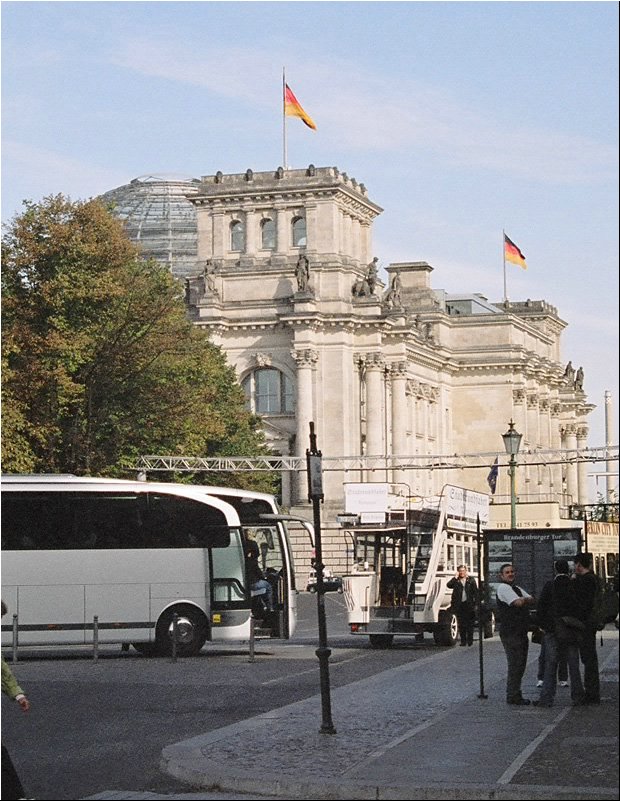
xmin=2 ymin=594 xmax=436 ymax=799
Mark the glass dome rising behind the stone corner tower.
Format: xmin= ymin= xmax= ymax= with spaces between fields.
xmin=100 ymin=175 xmax=200 ymax=278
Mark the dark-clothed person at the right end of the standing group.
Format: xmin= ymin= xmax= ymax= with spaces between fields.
xmin=574 ymin=553 xmax=601 ymax=704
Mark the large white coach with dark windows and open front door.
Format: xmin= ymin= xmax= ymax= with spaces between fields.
xmin=2 ymin=475 xmax=296 ymax=655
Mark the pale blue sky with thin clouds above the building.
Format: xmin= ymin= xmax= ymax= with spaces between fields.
xmin=2 ymin=2 xmax=620 ymax=456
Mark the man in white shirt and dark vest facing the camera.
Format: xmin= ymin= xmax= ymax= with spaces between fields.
xmin=497 ymin=563 xmax=534 ymax=706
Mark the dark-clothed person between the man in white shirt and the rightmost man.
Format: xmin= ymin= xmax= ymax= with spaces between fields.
xmin=534 ymin=559 xmax=584 ymax=706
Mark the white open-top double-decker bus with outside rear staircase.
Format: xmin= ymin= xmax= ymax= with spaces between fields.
xmin=343 ymin=484 xmax=493 ymax=648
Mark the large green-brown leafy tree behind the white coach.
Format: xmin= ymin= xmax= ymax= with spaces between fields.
xmin=2 ymin=195 xmax=270 ymax=489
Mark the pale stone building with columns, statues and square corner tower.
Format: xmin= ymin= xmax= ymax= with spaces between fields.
xmin=104 ymin=165 xmax=594 ymax=574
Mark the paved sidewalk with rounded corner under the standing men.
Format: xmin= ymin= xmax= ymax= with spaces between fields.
xmin=160 ymin=628 xmax=618 ymax=801
